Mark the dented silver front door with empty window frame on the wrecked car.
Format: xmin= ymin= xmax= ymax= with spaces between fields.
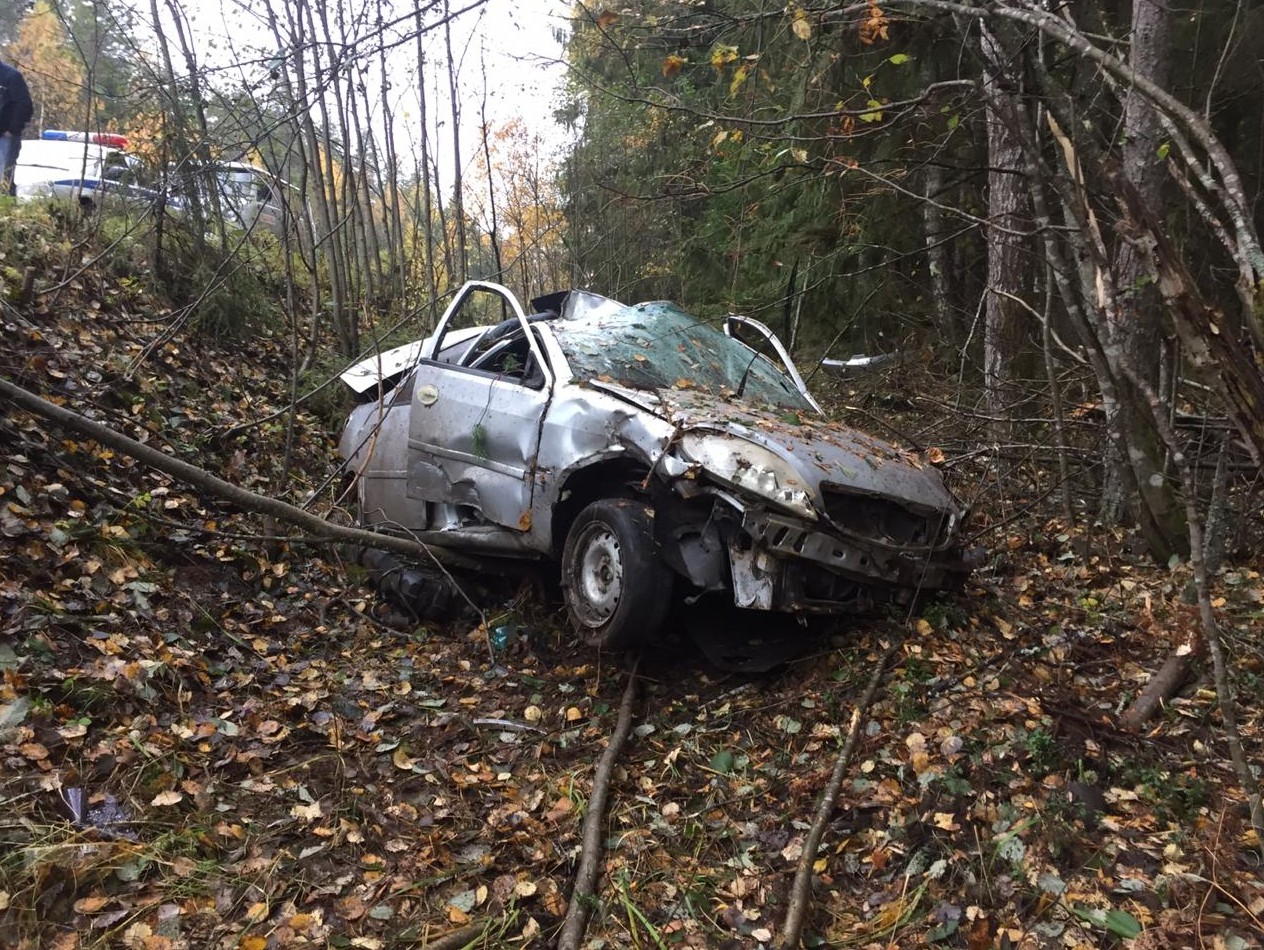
xmin=407 ymin=282 xmax=552 ymax=532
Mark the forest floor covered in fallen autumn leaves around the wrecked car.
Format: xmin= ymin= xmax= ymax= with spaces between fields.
xmin=0 ymin=246 xmax=1264 ymax=950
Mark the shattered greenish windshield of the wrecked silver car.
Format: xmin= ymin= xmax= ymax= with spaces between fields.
xmin=552 ymin=301 xmax=811 ymax=409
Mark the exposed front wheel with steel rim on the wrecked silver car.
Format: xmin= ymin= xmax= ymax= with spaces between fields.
xmin=561 ymin=498 xmax=672 ymax=649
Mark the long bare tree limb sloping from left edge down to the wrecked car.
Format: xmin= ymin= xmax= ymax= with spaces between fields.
xmin=0 ymin=378 xmax=436 ymax=561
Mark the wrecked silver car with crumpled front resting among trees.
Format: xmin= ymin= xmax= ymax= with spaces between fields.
xmin=339 ymin=282 xmax=969 ymax=647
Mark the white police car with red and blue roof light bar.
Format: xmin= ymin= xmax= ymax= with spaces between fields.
xmin=14 ymin=130 xmax=159 ymax=208
